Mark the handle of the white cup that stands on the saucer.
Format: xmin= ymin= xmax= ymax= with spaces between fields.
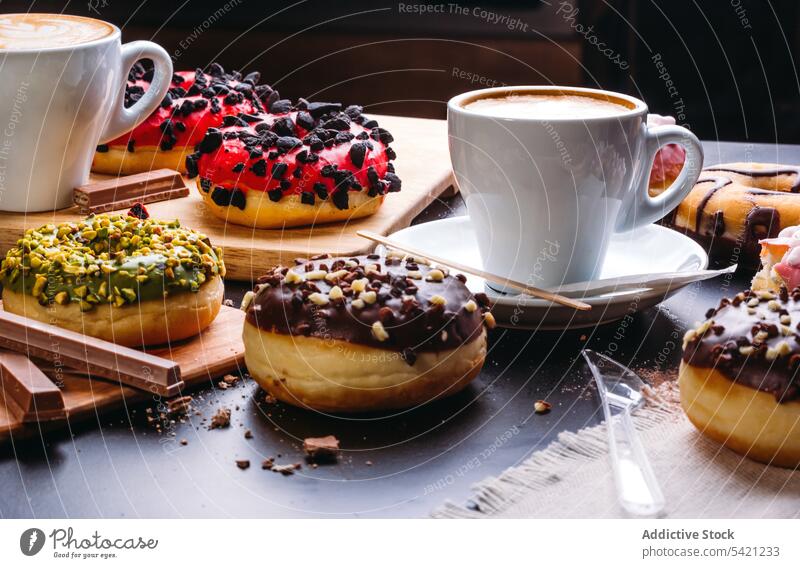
xmin=617 ymin=125 xmax=703 ymax=233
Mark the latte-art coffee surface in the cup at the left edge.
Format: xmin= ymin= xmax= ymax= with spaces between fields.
xmin=0 ymin=14 xmax=115 ymax=50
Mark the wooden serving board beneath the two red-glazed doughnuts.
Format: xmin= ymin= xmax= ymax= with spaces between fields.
xmin=0 ymin=116 xmax=453 ymax=281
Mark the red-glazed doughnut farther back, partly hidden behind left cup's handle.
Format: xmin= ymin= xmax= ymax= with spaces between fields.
xmin=92 ymin=63 xmax=266 ymax=175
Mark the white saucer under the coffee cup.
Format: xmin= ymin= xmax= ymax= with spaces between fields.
xmin=391 ymin=217 xmax=708 ymax=330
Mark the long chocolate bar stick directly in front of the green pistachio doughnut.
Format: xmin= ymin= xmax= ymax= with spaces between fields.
xmin=0 ymin=310 xmax=183 ymax=396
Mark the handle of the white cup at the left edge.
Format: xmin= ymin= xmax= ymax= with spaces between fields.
xmin=99 ymin=41 xmax=172 ymax=144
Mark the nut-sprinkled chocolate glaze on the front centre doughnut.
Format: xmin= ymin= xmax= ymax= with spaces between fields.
xmin=247 ymin=253 xmax=488 ymax=365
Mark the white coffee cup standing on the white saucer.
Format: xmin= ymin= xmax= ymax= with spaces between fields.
xmin=447 ymin=86 xmax=703 ymax=288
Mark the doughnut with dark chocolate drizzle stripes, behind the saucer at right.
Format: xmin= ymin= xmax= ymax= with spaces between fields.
xmin=668 ymin=163 xmax=800 ymax=269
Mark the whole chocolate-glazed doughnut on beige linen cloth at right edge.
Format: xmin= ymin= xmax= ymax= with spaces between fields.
xmin=679 ymin=288 xmax=800 ymax=467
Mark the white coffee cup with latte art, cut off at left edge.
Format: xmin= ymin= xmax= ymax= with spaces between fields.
xmin=0 ymin=14 xmax=172 ymax=212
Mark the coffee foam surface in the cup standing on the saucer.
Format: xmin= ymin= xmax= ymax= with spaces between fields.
xmin=464 ymin=94 xmax=630 ymax=119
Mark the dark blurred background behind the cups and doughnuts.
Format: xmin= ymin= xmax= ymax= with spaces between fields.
xmin=0 ymin=0 xmax=800 ymax=143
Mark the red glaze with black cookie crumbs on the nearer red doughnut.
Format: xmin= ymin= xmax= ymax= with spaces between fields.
xmin=184 ymin=97 xmax=402 ymax=210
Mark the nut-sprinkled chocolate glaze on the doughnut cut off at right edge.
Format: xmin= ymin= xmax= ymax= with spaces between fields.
xmin=683 ymin=288 xmax=800 ymax=402
